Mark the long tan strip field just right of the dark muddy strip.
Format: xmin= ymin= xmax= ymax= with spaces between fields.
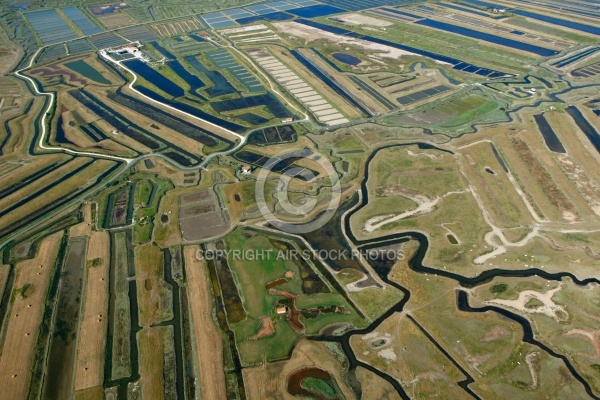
xmin=71 ymin=227 xmax=110 ymax=390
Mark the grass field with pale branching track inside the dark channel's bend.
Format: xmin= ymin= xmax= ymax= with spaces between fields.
xmin=351 ymin=146 xmax=489 ymax=275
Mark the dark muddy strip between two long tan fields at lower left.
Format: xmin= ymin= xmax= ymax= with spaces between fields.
xmin=44 ymin=237 xmax=87 ymax=400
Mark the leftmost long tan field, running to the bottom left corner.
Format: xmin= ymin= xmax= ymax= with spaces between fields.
xmin=0 ymin=232 xmax=62 ymax=399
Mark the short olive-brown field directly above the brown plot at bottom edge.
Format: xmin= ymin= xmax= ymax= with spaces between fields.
xmin=135 ymin=243 xmax=173 ymax=327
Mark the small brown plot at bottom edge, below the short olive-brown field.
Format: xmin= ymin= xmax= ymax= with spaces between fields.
xmin=137 ymin=327 xmax=169 ymax=400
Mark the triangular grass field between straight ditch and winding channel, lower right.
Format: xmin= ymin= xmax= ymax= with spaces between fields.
xmin=390 ymin=244 xmax=585 ymax=399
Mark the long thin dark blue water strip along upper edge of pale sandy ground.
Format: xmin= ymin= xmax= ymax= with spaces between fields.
xmin=296 ymin=18 xmax=510 ymax=78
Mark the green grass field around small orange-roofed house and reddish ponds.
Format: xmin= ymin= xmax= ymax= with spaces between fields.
xmin=226 ymin=229 xmax=362 ymax=365
